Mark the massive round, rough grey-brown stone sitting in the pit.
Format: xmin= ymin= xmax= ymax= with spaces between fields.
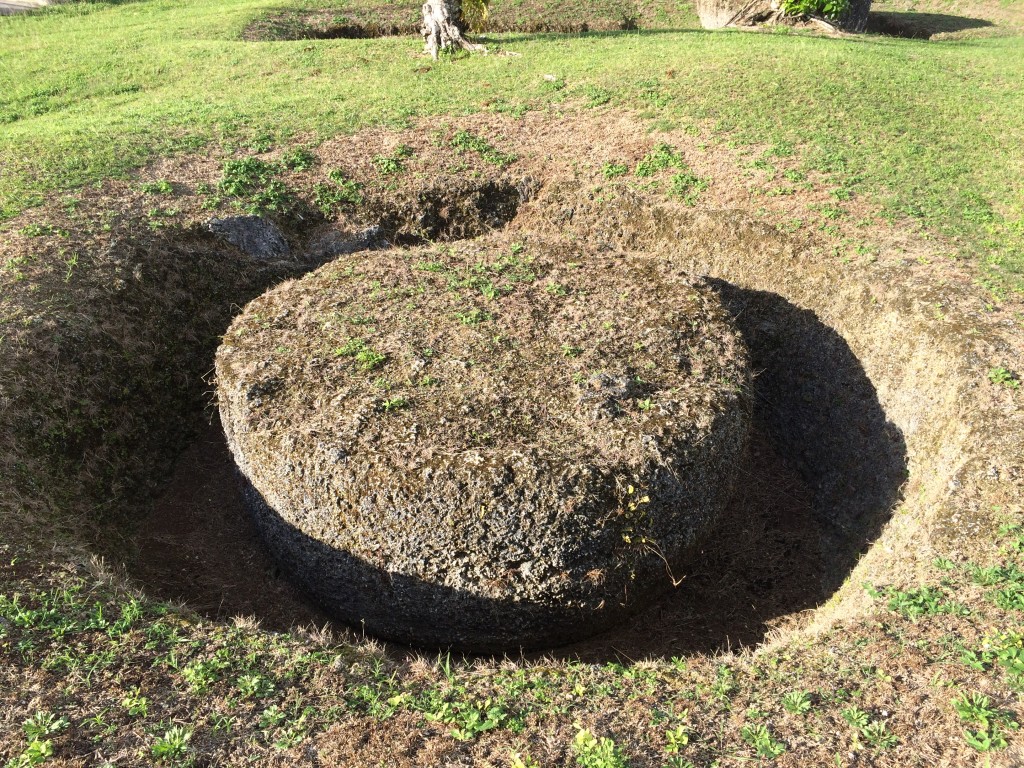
xmin=216 ymin=238 xmax=751 ymax=652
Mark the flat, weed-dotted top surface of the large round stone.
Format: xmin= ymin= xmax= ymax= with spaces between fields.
xmin=218 ymin=239 xmax=748 ymax=473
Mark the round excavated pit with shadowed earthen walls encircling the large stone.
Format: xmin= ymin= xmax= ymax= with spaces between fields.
xmin=8 ymin=166 xmax=1012 ymax=660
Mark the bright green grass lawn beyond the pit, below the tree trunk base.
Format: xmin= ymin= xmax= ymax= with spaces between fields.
xmin=0 ymin=0 xmax=1024 ymax=287
